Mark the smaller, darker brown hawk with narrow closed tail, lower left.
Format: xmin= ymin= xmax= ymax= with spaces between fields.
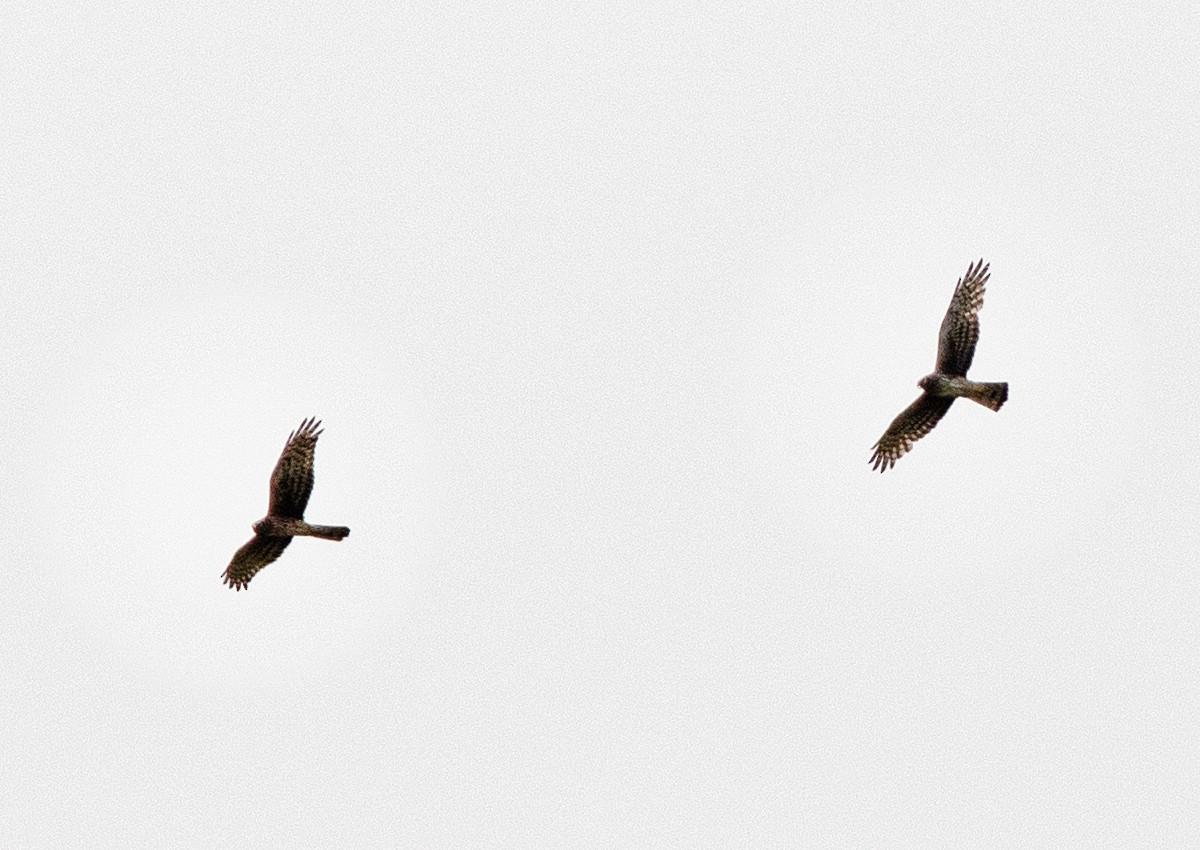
xmin=224 ymin=419 xmax=350 ymax=591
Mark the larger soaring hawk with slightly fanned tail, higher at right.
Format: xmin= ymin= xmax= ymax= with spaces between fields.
xmin=869 ymin=259 xmax=1008 ymax=472
